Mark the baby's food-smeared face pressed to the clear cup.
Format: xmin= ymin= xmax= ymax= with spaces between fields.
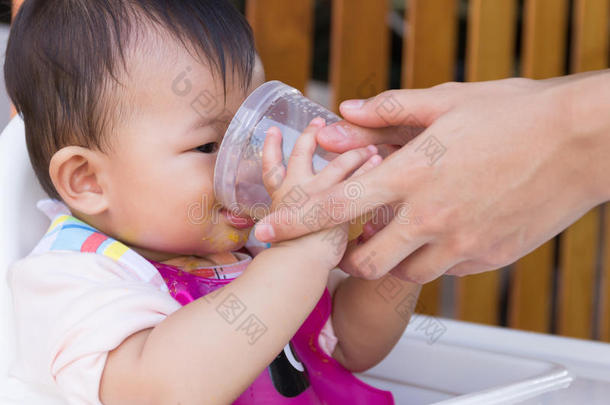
xmin=100 ymin=43 xmax=264 ymax=260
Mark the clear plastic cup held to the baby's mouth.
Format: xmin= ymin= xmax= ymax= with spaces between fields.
xmin=214 ymin=80 xmax=341 ymax=219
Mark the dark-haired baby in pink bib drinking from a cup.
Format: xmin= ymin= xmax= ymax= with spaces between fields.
xmin=5 ymin=0 xmax=419 ymax=405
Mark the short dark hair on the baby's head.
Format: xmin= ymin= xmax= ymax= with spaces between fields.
xmin=4 ymin=0 xmax=255 ymax=199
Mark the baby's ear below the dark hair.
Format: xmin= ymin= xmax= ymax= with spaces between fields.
xmin=49 ymin=146 xmax=108 ymax=215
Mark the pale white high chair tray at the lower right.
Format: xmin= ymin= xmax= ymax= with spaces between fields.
xmin=358 ymin=315 xmax=610 ymax=405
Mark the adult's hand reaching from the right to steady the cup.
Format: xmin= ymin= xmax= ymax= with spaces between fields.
xmin=256 ymin=71 xmax=610 ymax=283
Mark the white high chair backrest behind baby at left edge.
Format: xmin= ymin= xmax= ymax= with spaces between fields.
xmin=0 ymin=115 xmax=64 ymax=405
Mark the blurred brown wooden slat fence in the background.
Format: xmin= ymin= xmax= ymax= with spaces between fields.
xmin=0 ymin=0 xmax=610 ymax=341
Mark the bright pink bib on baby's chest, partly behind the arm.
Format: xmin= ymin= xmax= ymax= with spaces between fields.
xmin=151 ymin=261 xmax=394 ymax=405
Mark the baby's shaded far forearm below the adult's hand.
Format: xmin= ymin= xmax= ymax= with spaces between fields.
xmin=332 ymin=274 xmax=421 ymax=372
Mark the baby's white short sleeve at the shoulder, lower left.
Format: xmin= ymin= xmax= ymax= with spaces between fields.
xmin=7 ymin=252 xmax=181 ymax=405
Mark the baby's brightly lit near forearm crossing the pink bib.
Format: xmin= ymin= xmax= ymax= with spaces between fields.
xmin=117 ymin=247 xmax=330 ymax=405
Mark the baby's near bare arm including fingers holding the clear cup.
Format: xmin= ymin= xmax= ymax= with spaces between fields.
xmin=100 ymin=120 xmax=374 ymax=405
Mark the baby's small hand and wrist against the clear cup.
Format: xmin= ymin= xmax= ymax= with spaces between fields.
xmin=263 ymin=118 xmax=382 ymax=268
